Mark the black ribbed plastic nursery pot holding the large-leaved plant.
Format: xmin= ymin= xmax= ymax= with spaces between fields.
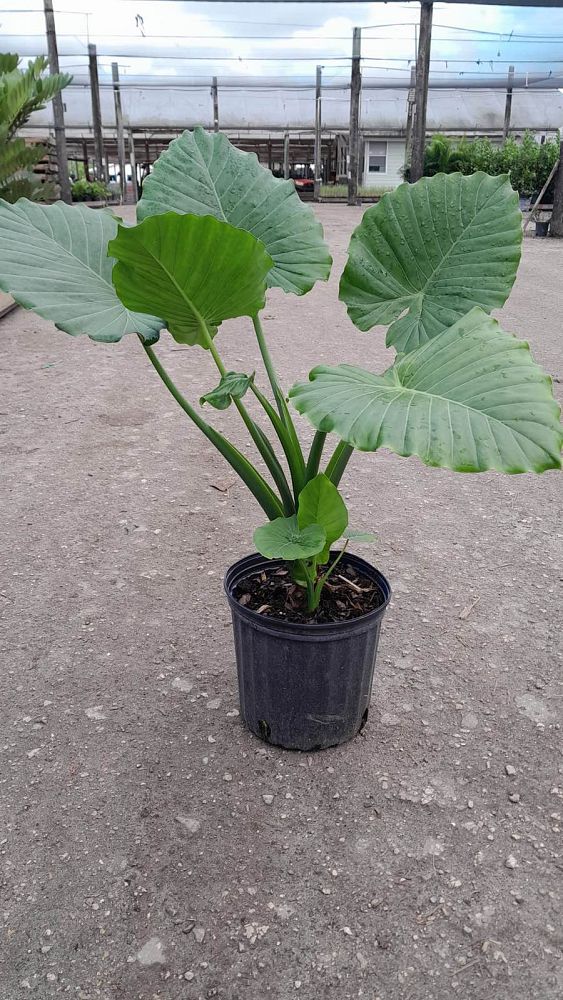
xmin=225 ymin=555 xmax=391 ymax=751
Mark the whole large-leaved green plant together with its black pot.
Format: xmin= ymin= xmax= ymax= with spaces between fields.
xmin=0 ymin=129 xmax=561 ymax=750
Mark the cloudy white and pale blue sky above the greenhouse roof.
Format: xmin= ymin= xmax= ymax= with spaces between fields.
xmin=0 ymin=0 xmax=563 ymax=83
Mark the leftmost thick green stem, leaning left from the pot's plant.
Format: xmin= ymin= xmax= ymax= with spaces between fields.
xmin=139 ymin=337 xmax=284 ymax=521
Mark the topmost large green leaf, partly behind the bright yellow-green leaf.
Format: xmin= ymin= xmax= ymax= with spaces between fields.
xmin=137 ymin=128 xmax=332 ymax=295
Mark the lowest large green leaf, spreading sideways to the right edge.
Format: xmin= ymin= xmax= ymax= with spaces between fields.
xmin=289 ymin=308 xmax=561 ymax=472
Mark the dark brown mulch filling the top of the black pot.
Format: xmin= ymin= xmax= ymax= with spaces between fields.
xmin=234 ymin=558 xmax=384 ymax=625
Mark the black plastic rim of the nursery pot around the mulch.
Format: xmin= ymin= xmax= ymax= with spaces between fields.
xmin=223 ymin=550 xmax=391 ymax=636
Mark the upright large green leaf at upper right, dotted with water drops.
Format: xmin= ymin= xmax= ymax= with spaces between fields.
xmin=340 ymin=173 xmax=522 ymax=352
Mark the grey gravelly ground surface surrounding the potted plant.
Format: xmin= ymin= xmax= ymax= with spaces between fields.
xmin=0 ymin=206 xmax=563 ymax=1000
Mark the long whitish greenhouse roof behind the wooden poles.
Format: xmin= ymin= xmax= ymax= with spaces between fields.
xmin=29 ymin=84 xmax=563 ymax=135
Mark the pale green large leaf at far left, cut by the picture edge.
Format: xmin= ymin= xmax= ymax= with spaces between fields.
xmin=0 ymin=199 xmax=163 ymax=342
